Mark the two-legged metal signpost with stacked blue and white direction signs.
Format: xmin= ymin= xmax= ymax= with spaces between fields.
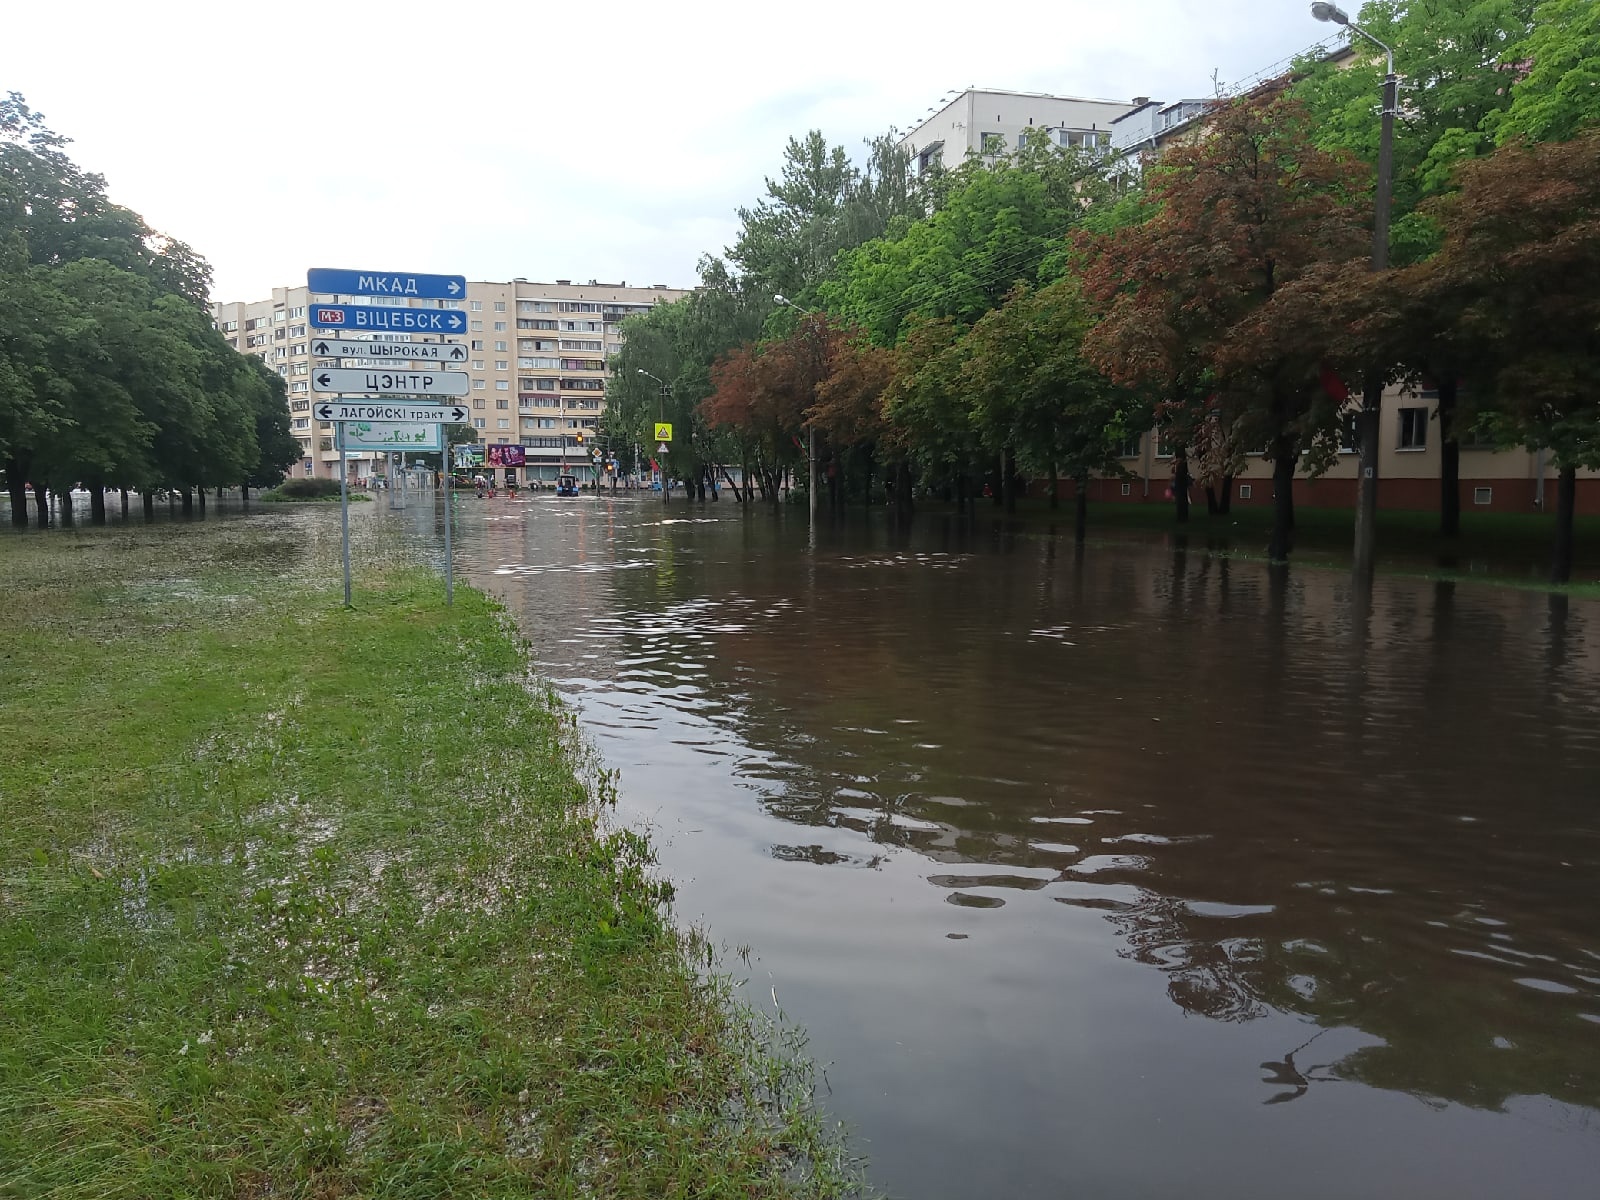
xmin=306 ymin=267 xmax=472 ymax=608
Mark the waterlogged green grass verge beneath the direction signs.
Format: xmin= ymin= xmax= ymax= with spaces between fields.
xmin=0 ymin=521 xmax=854 ymax=1197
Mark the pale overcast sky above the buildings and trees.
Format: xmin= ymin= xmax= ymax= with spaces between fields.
xmin=0 ymin=0 xmax=1355 ymax=301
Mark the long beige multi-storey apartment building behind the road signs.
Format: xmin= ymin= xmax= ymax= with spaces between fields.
xmin=211 ymin=278 xmax=688 ymax=480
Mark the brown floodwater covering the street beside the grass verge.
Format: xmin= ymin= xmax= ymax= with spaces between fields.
xmin=416 ymin=496 xmax=1600 ymax=1200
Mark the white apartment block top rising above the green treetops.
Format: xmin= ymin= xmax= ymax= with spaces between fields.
xmin=899 ymin=88 xmax=1144 ymax=173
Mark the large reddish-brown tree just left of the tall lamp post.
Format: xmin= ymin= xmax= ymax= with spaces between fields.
xmin=1078 ymin=85 xmax=1366 ymax=562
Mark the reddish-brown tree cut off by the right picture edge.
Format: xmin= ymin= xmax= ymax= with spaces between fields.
xmin=1397 ymin=130 xmax=1600 ymax=582
